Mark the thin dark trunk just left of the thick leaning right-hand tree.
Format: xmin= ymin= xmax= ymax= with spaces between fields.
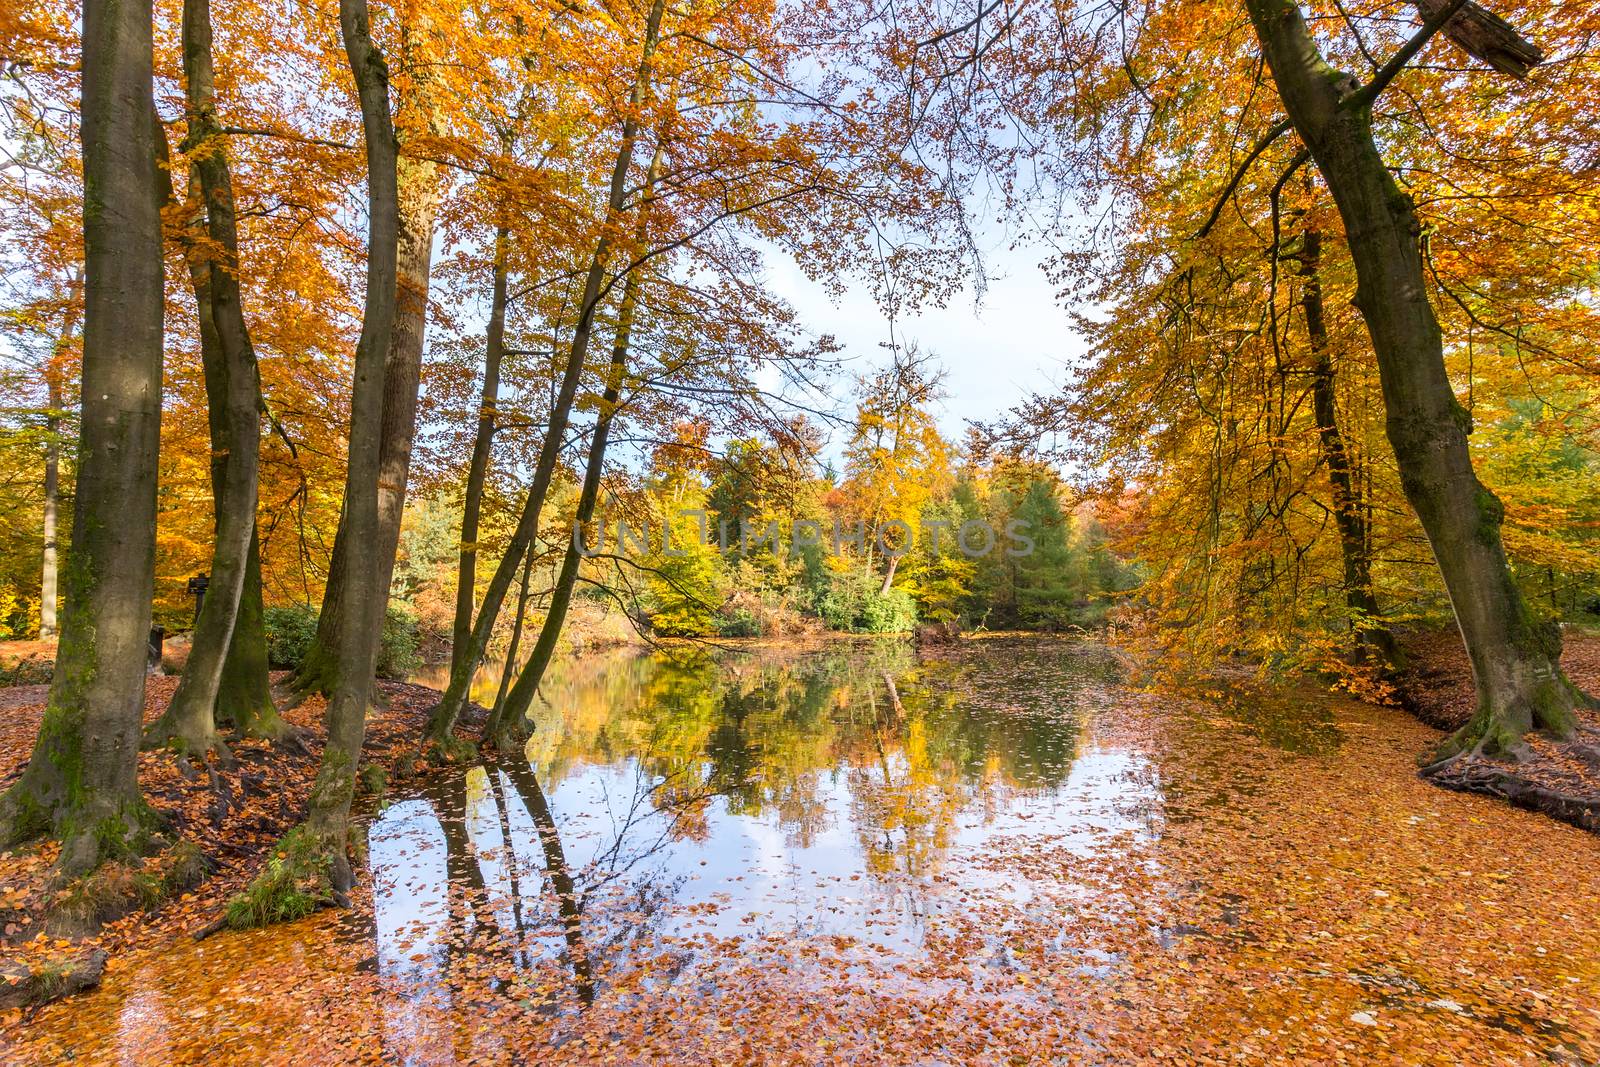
xmin=1299 ymin=229 xmax=1400 ymax=670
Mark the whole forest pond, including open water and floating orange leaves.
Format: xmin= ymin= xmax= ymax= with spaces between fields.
xmin=12 ymin=638 xmax=1600 ymax=1064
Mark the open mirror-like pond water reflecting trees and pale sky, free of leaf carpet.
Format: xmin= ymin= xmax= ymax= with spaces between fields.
xmin=370 ymin=643 xmax=1160 ymax=1038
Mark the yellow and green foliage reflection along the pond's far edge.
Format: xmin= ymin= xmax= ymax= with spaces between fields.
xmin=530 ymin=641 xmax=1088 ymax=873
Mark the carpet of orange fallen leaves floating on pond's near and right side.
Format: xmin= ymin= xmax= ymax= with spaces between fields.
xmin=0 ymin=641 xmax=1600 ymax=1064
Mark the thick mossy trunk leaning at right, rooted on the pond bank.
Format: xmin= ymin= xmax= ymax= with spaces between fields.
xmin=1246 ymin=0 xmax=1581 ymax=760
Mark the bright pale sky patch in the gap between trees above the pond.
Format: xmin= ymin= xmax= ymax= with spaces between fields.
xmin=766 ymin=233 xmax=1085 ymax=446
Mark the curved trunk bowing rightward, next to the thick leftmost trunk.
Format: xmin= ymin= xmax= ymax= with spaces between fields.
xmin=146 ymin=0 xmax=261 ymax=755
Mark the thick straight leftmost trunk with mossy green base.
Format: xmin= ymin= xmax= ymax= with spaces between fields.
xmin=0 ymin=0 xmax=163 ymax=875
